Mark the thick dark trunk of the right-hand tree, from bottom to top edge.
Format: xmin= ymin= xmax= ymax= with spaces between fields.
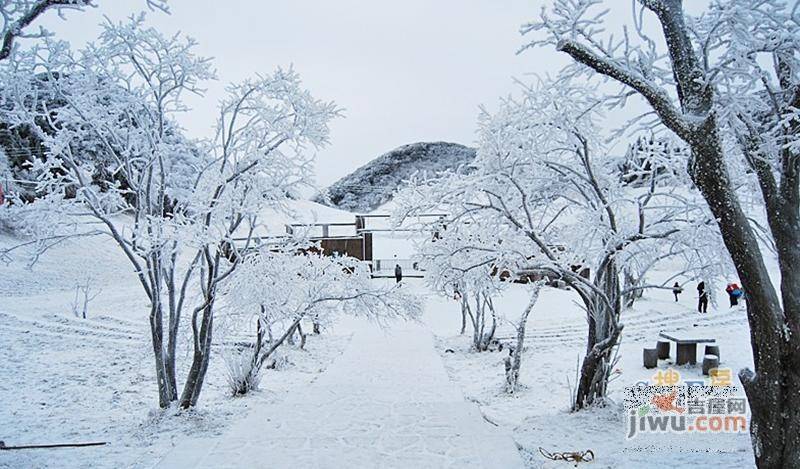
xmin=654 ymin=0 xmax=800 ymax=462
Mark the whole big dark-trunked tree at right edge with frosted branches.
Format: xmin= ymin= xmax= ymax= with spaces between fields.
xmin=523 ymin=0 xmax=800 ymax=468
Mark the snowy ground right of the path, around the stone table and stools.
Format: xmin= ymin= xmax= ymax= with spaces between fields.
xmin=429 ymin=280 xmax=753 ymax=468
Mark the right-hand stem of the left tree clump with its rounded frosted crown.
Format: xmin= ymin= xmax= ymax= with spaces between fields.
xmin=175 ymin=64 xmax=339 ymax=407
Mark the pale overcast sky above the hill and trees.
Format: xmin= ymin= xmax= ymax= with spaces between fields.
xmin=32 ymin=0 xmax=712 ymax=186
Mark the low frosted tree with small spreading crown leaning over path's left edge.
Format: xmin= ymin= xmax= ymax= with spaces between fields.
xmin=222 ymin=246 xmax=422 ymax=394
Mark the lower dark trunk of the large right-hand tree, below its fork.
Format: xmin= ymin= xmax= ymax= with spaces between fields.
xmin=689 ymin=121 xmax=800 ymax=468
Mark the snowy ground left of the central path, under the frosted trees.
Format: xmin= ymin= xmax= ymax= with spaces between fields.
xmin=0 ymin=232 xmax=350 ymax=468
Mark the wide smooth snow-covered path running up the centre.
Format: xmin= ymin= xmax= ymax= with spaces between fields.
xmin=159 ymin=325 xmax=523 ymax=468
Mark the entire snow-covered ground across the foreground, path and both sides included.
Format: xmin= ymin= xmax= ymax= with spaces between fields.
xmin=0 ymin=224 xmax=752 ymax=468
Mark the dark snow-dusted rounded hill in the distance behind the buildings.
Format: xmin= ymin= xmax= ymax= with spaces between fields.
xmin=313 ymin=142 xmax=476 ymax=212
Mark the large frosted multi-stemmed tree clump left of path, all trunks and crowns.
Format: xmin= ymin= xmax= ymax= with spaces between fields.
xmin=2 ymin=17 xmax=338 ymax=407
